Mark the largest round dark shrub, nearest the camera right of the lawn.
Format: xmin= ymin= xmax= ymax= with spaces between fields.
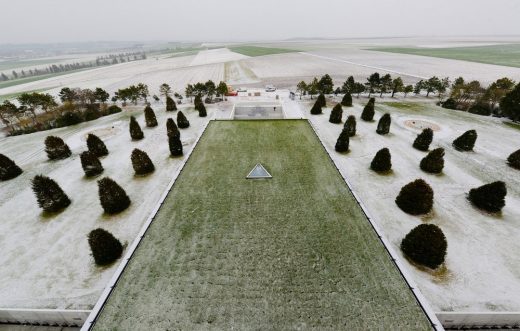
xmin=401 ymin=224 xmax=448 ymax=269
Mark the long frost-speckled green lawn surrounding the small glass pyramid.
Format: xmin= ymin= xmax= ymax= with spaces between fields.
xmin=94 ymin=120 xmax=430 ymax=330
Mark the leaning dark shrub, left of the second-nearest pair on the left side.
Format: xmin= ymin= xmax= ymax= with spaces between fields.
xmin=32 ymin=175 xmax=70 ymax=213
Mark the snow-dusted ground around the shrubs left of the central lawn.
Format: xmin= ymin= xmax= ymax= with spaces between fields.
xmin=0 ymin=105 xmax=216 ymax=309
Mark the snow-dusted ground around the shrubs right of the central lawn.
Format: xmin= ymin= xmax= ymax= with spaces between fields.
xmin=301 ymin=98 xmax=520 ymax=312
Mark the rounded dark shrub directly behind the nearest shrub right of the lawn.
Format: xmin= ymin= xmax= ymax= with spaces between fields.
xmin=395 ymin=179 xmax=433 ymax=215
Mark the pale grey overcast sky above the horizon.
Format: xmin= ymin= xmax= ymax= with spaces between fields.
xmin=0 ymin=0 xmax=520 ymax=43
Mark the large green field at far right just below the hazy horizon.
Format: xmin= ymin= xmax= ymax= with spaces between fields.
xmin=370 ymin=44 xmax=520 ymax=67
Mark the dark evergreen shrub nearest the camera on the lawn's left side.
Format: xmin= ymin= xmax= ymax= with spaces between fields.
xmin=88 ymin=228 xmax=123 ymax=266
